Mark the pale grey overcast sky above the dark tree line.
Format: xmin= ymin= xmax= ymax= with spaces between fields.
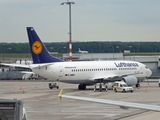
xmin=0 ymin=0 xmax=160 ymax=43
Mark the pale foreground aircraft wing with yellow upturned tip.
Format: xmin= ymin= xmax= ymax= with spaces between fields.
xmin=58 ymin=89 xmax=160 ymax=112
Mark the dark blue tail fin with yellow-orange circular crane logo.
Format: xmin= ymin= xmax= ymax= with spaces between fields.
xmin=27 ymin=27 xmax=63 ymax=64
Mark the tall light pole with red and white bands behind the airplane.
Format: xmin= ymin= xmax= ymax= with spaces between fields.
xmin=61 ymin=0 xmax=75 ymax=61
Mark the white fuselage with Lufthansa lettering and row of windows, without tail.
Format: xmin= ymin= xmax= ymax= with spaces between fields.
xmin=32 ymin=61 xmax=151 ymax=85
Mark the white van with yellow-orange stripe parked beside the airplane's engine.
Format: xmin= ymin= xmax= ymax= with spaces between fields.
xmin=113 ymin=81 xmax=134 ymax=92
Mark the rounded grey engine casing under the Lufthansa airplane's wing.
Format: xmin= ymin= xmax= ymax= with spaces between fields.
xmin=123 ymin=75 xmax=138 ymax=86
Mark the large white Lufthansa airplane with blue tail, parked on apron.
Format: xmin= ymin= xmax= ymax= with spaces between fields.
xmin=1 ymin=27 xmax=152 ymax=90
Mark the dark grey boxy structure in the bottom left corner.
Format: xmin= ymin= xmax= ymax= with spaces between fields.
xmin=0 ymin=99 xmax=27 ymax=120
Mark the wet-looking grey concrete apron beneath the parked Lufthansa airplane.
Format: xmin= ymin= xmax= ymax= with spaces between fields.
xmin=0 ymin=80 xmax=160 ymax=120
